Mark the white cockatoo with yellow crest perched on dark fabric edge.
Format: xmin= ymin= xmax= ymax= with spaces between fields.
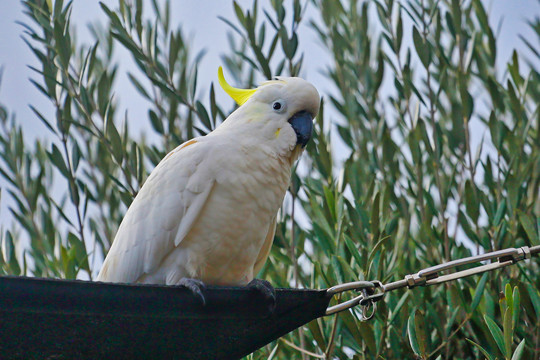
xmin=97 ymin=67 xmax=320 ymax=301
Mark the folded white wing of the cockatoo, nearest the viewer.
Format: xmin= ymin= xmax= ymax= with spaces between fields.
xmin=97 ymin=138 xmax=215 ymax=282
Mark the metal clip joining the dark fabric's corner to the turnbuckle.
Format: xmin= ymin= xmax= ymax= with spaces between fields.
xmin=326 ymin=280 xmax=384 ymax=320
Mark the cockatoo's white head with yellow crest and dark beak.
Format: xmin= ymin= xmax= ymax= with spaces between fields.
xmin=218 ymin=67 xmax=320 ymax=158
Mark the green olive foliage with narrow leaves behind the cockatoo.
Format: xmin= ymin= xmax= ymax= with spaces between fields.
xmin=0 ymin=0 xmax=540 ymax=359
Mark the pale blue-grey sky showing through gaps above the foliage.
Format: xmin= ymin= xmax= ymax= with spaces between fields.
xmin=0 ymin=0 xmax=540 ymax=141
